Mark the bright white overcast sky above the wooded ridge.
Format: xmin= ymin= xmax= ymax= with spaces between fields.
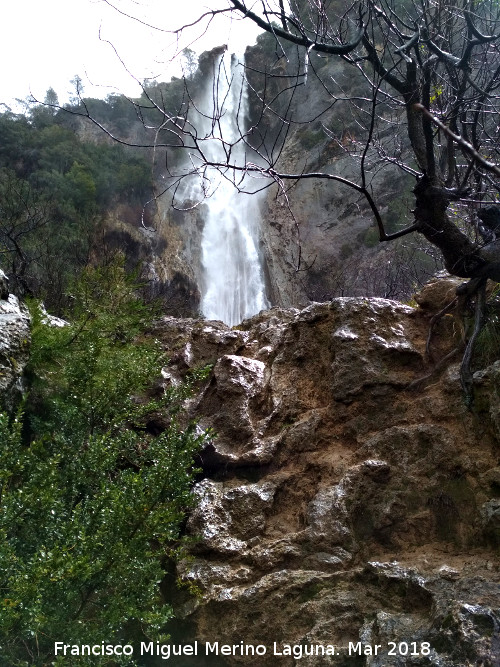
xmin=0 ymin=0 xmax=258 ymax=111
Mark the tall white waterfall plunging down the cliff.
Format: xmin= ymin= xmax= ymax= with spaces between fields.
xmin=186 ymin=53 xmax=269 ymax=326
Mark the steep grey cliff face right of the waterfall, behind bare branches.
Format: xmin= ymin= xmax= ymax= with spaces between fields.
xmin=245 ymin=43 xmax=437 ymax=307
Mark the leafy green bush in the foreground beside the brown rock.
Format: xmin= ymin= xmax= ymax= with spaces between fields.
xmin=0 ymin=260 xmax=204 ymax=666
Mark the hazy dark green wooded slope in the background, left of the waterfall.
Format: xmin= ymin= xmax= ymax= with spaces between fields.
xmin=0 ymin=104 xmax=150 ymax=314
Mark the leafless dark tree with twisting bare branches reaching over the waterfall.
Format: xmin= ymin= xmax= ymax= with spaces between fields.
xmin=62 ymin=0 xmax=500 ymax=400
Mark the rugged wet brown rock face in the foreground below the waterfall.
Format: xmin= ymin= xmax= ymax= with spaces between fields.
xmin=157 ymin=281 xmax=500 ymax=667
